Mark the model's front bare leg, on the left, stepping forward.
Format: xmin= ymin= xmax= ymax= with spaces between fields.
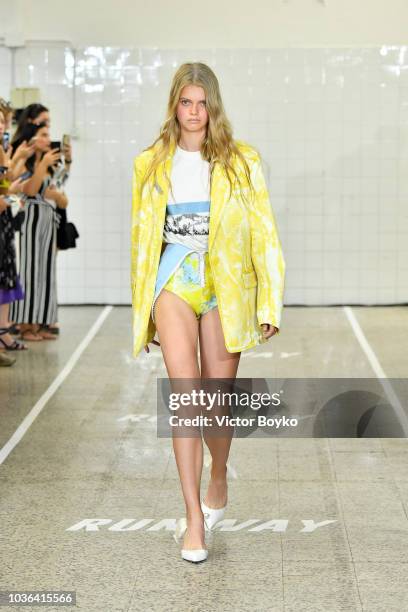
xmin=155 ymin=289 xmax=205 ymax=549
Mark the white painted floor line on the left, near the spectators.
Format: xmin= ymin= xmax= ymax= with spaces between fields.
xmin=0 ymin=306 xmax=113 ymax=465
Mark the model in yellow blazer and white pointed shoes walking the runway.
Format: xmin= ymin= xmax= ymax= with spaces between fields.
xmin=131 ymin=62 xmax=285 ymax=562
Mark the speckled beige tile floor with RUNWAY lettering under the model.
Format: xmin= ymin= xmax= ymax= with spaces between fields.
xmin=0 ymin=307 xmax=408 ymax=612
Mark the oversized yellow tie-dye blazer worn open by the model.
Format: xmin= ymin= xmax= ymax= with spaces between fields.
xmin=131 ymin=141 xmax=285 ymax=357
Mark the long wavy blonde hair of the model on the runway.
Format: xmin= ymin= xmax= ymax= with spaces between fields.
xmin=141 ymin=62 xmax=253 ymax=206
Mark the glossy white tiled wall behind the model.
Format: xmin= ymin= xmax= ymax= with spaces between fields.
xmin=0 ymin=44 xmax=408 ymax=304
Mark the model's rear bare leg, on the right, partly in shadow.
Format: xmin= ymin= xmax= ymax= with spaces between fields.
xmin=199 ymin=307 xmax=241 ymax=508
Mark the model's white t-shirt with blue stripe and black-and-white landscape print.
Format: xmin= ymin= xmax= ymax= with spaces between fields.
xmin=163 ymin=145 xmax=210 ymax=253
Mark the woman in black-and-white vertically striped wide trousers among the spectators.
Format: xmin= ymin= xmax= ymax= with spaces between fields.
xmin=10 ymin=122 xmax=61 ymax=341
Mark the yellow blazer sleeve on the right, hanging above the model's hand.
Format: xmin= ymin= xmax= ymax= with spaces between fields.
xmin=250 ymin=153 xmax=285 ymax=331
